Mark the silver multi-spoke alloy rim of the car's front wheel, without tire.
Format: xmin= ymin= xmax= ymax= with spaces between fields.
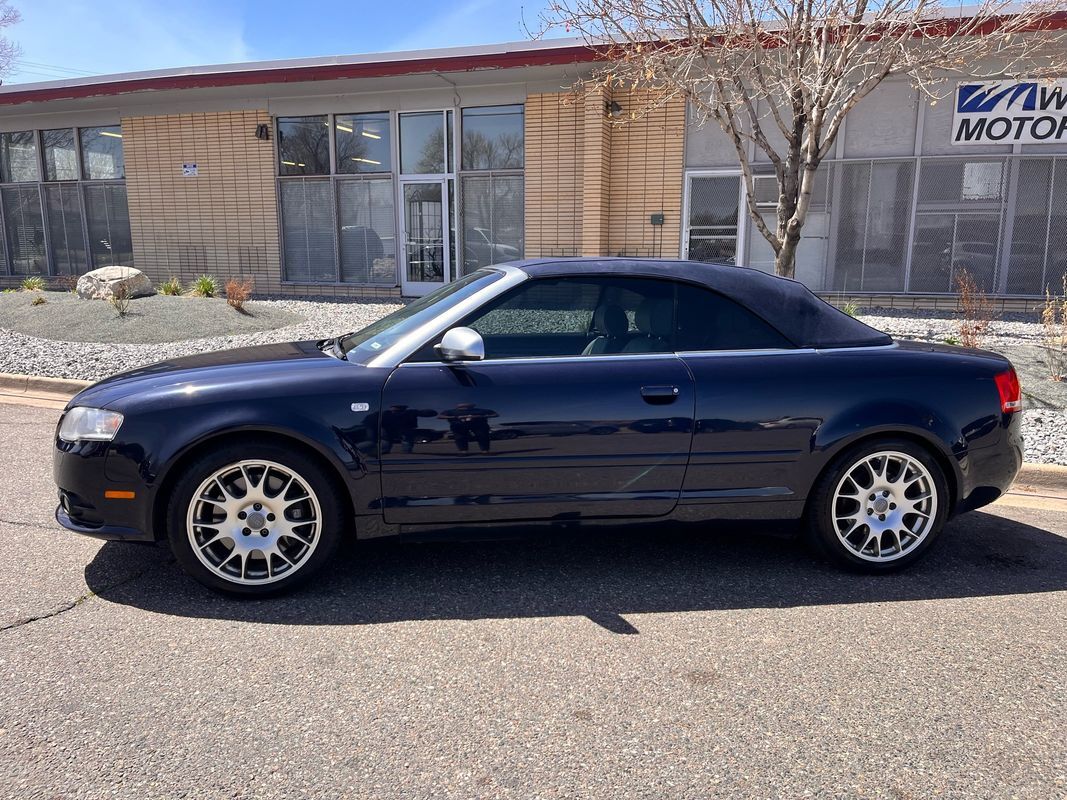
xmin=186 ymin=460 xmax=322 ymax=586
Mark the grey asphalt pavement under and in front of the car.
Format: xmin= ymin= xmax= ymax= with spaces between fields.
xmin=0 ymin=405 xmax=1067 ymax=800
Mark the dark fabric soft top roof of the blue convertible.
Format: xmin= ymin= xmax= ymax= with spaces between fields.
xmin=509 ymin=258 xmax=892 ymax=348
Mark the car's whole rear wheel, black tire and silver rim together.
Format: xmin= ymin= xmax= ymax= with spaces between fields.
xmin=807 ymin=439 xmax=950 ymax=573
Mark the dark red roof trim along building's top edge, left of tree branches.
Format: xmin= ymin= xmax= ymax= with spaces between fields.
xmin=0 ymin=45 xmax=603 ymax=106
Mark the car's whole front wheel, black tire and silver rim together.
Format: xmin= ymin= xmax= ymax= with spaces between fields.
xmin=168 ymin=445 xmax=344 ymax=596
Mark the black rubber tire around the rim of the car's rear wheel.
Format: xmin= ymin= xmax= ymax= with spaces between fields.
xmin=805 ymin=437 xmax=952 ymax=574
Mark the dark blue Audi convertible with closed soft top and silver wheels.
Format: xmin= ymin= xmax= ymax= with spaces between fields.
xmin=54 ymin=259 xmax=1022 ymax=595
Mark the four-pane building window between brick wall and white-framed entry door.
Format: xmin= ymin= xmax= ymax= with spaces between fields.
xmin=277 ymin=112 xmax=397 ymax=286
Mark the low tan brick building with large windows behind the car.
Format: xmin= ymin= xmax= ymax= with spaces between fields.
xmin=0 ymin=41 xmax=1067 ymax=304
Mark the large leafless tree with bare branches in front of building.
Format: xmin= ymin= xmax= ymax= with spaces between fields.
xmin=543 ymin=0 xmax=1067 ymax=276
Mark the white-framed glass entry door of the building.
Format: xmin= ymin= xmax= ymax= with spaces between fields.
xmin=400 ymin=180 xmax=451 ymax=297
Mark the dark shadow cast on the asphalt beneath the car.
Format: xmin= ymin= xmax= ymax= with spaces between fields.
xmin=85 ymin=512 xmax=1067 ymax=634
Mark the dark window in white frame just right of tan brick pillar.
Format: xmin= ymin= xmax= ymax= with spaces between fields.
xmin=686 ymin=175 xmax=740 ymax=263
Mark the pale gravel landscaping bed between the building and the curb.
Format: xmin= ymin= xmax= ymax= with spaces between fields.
xmin=0 ymin=292 xmax=1067 ymax=464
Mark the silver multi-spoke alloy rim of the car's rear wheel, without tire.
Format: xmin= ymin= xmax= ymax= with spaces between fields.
xmin=831 ymin=450 xmax=938 ymax=562
